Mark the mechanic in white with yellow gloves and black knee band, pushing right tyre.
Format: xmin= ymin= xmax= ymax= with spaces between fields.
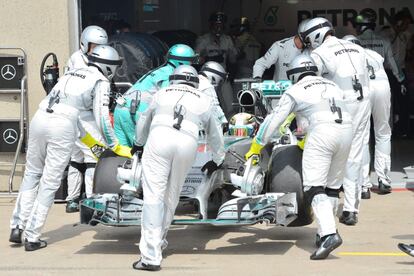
xmin=246 ymin=54 xmax=352 ymax=260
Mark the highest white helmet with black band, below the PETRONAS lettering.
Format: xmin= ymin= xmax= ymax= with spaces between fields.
xmin=300 ymin=17 xmax=334 ymax=49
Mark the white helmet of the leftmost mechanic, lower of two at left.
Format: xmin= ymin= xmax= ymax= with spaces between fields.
xmin=88 ymin=45 xmax=122 ymax=80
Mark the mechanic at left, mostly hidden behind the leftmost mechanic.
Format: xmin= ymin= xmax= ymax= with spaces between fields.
xmin=65 ymin=25 xmax=108 ymax=213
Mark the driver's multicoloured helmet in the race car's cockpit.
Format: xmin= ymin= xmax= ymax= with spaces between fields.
xmin=228 ymin=113 xmax=258 ymax=137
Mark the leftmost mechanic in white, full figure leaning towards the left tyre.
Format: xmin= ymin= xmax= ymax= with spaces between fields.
xmin=9 ymin=45 xmax=121 ymax=251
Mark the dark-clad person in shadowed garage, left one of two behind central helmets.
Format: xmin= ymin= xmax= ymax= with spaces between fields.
xmin=195 ymin=12 xmax=238 ymax=68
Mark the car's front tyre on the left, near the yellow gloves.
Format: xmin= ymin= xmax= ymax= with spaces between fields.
xmin=93 ymin=150 xmax=128 ymax=194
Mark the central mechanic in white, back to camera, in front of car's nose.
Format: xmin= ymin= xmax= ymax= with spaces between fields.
xmin=133 ymin=65 xmax=224 ymax=270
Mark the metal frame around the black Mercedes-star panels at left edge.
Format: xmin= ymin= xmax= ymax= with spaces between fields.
xmin=0 ymin=47 xmax=29 ymax=197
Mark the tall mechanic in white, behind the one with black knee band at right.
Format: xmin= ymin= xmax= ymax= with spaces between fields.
xmin=300 ymin=17 xmax=371 ymax=225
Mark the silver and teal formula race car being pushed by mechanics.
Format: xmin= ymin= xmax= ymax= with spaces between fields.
xmin=80 ymin=79 xmax=313 ymax=229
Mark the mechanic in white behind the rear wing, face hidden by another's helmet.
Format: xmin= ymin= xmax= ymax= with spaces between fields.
xmin=252 ymin=19 xmax=308 ymax=81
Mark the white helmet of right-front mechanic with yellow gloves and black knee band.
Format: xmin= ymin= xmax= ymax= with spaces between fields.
xmin=286 ymin=54 xmax=318 ymax=83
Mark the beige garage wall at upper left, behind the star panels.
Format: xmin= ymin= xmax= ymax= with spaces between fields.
xmin=0 ymin=0 xmax=73 ymax=121
